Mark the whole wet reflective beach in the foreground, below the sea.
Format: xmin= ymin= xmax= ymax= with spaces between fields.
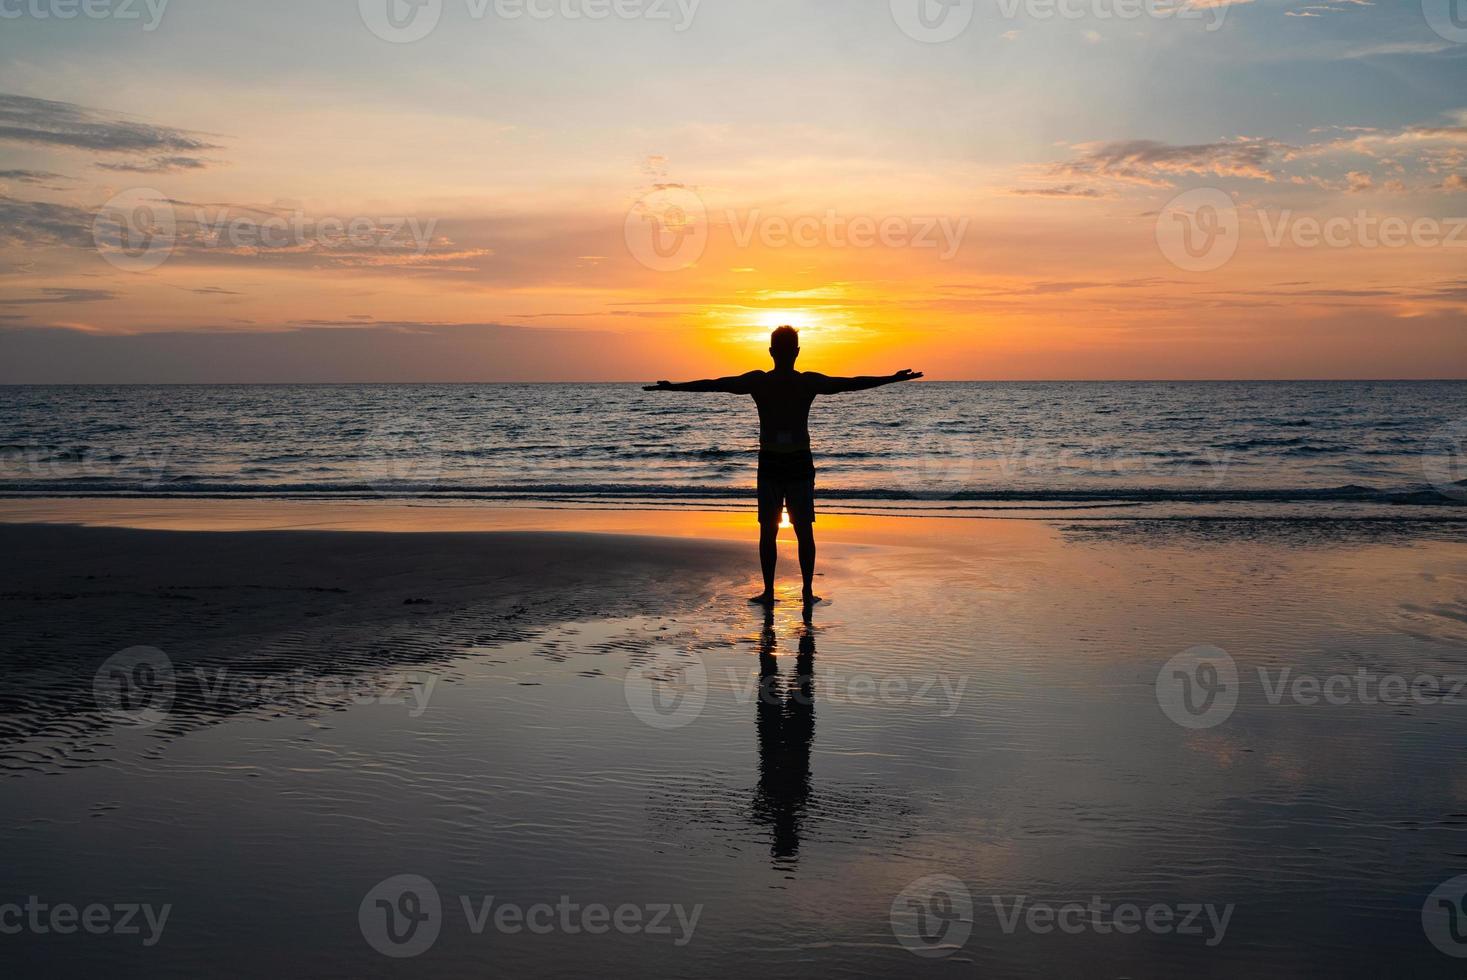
xmin=0 ymin=500 xmax=1467 ymax=977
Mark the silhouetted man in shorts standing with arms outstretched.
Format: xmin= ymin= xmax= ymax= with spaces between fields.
xmin=643 ymin=327 xmax=921 ymax=604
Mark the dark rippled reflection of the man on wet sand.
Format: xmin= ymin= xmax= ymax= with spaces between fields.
xmin=754 ymin=615 xmax=816 ymax=858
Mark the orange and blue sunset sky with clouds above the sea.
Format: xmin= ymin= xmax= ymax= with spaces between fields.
xmin=0 ymin=0 xmax=1467 ymax=381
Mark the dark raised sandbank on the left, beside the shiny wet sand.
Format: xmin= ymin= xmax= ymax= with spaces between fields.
xmin=0 ymin=524 xmax=738 ymax=770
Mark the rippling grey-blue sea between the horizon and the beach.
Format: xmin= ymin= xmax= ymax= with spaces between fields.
xmin=0 ymin=381 xmax=1467 ymax=512
